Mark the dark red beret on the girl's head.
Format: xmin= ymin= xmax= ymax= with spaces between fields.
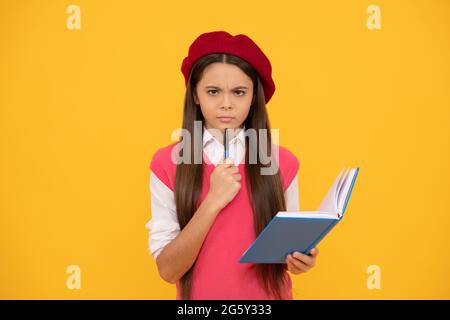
xmin=181 ymin=31 xmax=275 ymax=103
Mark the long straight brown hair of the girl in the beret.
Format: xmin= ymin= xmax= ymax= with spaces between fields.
xmin=174 ymin=53 xmax=286 ymax=299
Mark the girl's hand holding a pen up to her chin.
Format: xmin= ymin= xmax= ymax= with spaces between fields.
xmin=207 ymin=158 xmax=241 ymax=210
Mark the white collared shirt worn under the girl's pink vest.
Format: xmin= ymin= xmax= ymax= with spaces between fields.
xmin=145 ymin=127 xmax=300 ymax=259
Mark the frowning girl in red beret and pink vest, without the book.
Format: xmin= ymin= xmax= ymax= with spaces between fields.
xmin=146 ymin=31 xmax=318 ymax=299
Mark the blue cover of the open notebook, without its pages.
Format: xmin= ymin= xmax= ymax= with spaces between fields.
xmin=239 ymin=168 xmax=359 ymax=263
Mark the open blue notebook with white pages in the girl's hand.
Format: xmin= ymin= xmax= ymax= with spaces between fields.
xmin=239 ymin=168 xmax=359 ymax=263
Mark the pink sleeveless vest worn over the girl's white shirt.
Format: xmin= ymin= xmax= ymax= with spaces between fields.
xmin=150 ymin=142 xmax=299 ymax=300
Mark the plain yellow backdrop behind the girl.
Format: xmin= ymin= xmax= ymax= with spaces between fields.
xmin=0 ymin=0 xmax=450 ymax=299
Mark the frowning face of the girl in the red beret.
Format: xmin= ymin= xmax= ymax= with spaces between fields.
xmin=194 ymin=62 xmax=253 ymax=133
